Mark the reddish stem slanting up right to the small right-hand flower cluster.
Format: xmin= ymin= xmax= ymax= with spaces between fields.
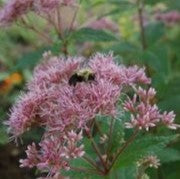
xmin=109 ymin=129 xmax=139 ymax=170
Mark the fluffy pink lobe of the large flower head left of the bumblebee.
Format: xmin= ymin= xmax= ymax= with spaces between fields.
xmin=28 ymin=55 xmax=82 ymax=90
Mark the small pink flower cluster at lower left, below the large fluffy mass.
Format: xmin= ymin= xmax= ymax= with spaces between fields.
xmin=20 ymin=131 xmax=84 ymax=176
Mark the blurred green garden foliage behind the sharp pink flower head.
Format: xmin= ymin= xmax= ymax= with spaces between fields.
xmin=0 ymin=0 xmax=180 ymax=179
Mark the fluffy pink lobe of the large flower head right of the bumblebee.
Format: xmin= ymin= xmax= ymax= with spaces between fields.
xmin=90 ymin=54 xmax=151 ymax=85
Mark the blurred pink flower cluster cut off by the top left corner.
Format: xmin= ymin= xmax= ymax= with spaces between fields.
xmin=0 ymin=0 xmax=76 ymax=25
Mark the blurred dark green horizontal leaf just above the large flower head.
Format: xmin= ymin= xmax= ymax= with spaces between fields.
xmin=70 ymin=28 xmax=117 ymax=42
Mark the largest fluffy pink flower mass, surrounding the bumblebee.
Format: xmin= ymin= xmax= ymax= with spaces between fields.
xmin=7 ymin=51 xmax=150 ymax=136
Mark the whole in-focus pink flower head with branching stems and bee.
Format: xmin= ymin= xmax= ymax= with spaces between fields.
xmin=7 ymin=52 xmax=178 ymax=178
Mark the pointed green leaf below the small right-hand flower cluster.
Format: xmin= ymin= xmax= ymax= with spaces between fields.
xmin=114 ymin=135 xmax=177 ymax=168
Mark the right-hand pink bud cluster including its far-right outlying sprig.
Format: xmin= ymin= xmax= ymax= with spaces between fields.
xmin=123 ymin=87 xmax=180 ymax=130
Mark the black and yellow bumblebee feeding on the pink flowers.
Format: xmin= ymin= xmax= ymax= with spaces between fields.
xmin=69 ymin=68 xmax=95 ymax=86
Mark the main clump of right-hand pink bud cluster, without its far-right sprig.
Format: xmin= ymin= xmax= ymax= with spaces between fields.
xmin=123 ymin=88 xmax=161 ymax=130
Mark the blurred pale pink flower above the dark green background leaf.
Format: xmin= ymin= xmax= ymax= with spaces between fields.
xmin=87 ymin=17 xmax=118 ymax=32
